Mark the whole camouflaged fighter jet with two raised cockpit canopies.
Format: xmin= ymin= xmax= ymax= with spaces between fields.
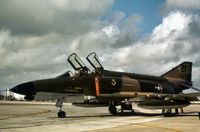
xmin=10 ymin=52 xmax=200 ymax=118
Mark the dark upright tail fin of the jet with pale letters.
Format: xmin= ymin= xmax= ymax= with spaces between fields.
xmin=162 ymin=62 xmax=192 ymax=82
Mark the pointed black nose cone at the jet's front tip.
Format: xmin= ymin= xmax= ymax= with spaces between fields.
xmin=10 ymin=82 xmax=36 ymax=95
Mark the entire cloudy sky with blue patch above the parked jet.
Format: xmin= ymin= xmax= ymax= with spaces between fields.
xmin=0 ymin=0 xmax=200 ymax=93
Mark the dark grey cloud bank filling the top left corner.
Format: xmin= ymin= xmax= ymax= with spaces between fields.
xmin=0 ymin=0 xmax=112 ymax=35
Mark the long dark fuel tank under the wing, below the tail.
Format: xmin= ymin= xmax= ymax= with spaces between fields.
xmin=138 ymin=100 xmax=190 ymax=109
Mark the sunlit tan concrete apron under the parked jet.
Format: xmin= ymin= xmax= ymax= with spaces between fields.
xmin=0 ymin=101 xmax=200 ymax=132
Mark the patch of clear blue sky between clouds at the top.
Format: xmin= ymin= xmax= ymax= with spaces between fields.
xmin=102 ymin=0 xmax=164 ymax=35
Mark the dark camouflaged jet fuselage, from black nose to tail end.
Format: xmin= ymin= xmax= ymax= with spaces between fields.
xmin=11 ymin=70 xmax=186 ymax=98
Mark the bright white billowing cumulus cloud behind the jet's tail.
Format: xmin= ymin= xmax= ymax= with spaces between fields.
xmin=104 ymin=11 xmax=200 ymax=82
